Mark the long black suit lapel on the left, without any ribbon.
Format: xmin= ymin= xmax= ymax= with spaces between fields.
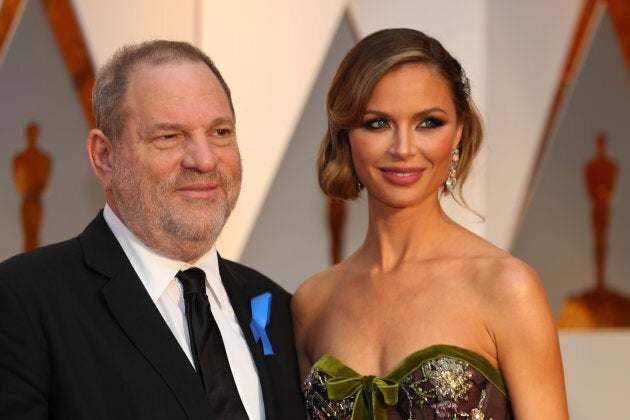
xmin=79 ymin=213 xmax=211 ymax=418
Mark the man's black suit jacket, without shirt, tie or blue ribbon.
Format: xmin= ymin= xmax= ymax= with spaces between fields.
xmin=0 ymin=213 xmax=305 ymax=420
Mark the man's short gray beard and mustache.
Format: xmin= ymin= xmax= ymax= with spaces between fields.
xmin=111 ymin=157 xmax=240 ymax=245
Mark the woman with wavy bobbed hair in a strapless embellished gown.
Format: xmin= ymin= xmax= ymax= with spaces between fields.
xmin=293 ymin=29 xmax=568 ymax=420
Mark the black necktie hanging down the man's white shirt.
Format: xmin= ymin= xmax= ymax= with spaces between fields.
xmin=176 ymin=267 xmax=248 ymax=420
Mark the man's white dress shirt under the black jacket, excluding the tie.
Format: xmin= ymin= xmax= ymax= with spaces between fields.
xmin=103 ymin=205 xmax=265 ymax=420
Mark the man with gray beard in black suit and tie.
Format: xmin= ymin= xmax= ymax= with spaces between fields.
xmin=0 ymin=41 xmax=304 ymax=420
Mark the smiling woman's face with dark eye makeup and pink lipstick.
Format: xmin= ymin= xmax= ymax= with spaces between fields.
xmin=349 ymin=63 xmax=462 ymax=212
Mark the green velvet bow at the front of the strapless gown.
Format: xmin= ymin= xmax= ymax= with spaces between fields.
xmin=328 ymin=375 xmax=399 ymax=420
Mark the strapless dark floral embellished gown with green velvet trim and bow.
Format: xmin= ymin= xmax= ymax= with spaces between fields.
xmin=304 ymin=345 xmax=514 ymax=420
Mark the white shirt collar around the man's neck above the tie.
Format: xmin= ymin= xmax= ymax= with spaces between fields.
xmin=103 ymin=204 xmax=224 ymax=305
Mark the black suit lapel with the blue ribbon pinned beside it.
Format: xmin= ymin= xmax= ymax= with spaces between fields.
xmin=219 ymin=256 xmax=275 ymax=418
